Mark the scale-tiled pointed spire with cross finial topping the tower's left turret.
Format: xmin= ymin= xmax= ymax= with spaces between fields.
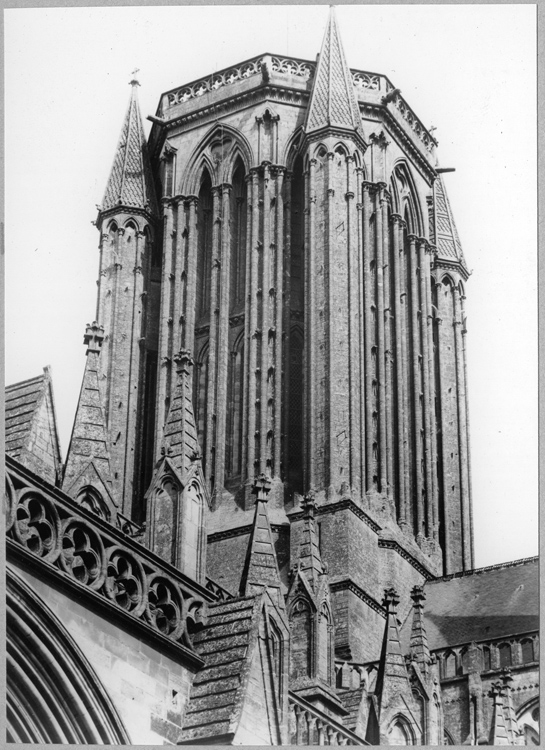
xmin=101 ymin=79 xmax=157 ymax=214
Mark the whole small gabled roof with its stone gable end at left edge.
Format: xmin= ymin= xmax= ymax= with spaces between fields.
xmin=5 ymin=367 xmax=61 ymax=484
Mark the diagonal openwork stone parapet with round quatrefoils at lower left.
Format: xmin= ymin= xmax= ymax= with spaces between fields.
xmin=5 ymin=461 xmax=210 ymax=649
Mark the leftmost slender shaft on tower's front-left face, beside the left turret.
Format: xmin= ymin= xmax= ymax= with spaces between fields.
xmin=154 ymin=199 xmax=174 ymax=460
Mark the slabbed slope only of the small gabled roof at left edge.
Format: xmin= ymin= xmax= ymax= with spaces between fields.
xmin=5 ymin=371 xmax=47 ymax=458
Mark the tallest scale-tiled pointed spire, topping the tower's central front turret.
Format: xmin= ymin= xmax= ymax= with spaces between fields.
xmin=305 ymin=7 xmax=361 ymax=134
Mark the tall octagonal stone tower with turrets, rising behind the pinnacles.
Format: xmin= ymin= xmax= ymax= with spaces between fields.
xmin=71 ymin=11 xmax=473 ymax=660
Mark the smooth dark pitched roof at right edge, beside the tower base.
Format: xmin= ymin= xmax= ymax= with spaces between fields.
xmin=401 ymin=557 xmax=539 ymax=653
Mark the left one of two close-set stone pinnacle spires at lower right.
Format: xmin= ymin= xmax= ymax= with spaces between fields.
xmin=375 ymin=588 xmax=410 ymax=713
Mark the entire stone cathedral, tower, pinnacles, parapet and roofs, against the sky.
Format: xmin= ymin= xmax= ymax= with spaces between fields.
xmin=9 ymin=11 xmax=539 ymax=746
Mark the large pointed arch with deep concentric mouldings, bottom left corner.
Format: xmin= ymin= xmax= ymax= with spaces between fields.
xmin=6 ymin=569 xmax=131 ymax=745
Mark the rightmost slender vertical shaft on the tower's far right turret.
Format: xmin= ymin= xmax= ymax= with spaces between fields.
xmin=453 ymin=287 xmax=473 ymax=570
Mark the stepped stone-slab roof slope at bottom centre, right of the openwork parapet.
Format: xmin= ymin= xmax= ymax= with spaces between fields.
xmin=180 ymin=596 xmax=257 ymax=744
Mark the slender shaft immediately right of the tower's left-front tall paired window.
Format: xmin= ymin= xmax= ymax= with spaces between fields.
xmin=247 ymin=170 xmax=259 ymax=479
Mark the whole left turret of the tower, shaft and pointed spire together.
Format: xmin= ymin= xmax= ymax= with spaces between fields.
xmin=90 ymin=78 xmax=160 ymax=522
